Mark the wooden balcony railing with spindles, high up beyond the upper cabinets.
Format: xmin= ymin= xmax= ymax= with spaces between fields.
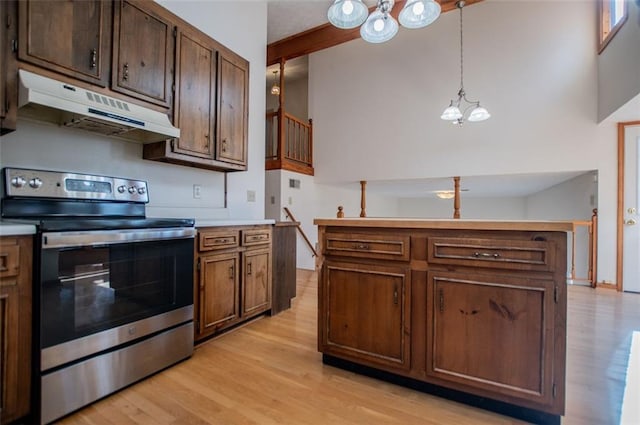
xmin=265 ymin=109 xmax=313 ymax=176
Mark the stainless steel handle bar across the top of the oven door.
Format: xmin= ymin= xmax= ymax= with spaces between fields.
xmin=42 ymin=227 xmax=196 ymax=249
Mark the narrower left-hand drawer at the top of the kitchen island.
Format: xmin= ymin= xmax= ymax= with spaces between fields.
xmin=324 ymin=233 xmax=409 ymax=261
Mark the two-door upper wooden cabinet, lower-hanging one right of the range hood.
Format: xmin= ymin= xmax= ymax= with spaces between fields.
xmin=143 ymin=27 xmax=249 ymax=171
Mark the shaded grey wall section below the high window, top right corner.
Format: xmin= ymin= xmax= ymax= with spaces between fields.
xmin=598 ymin=1 xmax=640 ymax=121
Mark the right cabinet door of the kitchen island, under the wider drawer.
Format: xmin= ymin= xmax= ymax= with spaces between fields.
xmin=426 ymin=271 xmax=564 ymax=413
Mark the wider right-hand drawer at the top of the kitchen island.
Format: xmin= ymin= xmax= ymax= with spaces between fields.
xmin=427 ymin=238 xmax=556 ymax=271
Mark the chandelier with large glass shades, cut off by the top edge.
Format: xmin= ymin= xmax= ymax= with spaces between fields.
xmin=327 ymin=0 xmax=440 ymax=43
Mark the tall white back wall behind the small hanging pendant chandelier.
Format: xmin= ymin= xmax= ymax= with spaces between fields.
xmin=309 ymin=0 xmax=617 ymax=280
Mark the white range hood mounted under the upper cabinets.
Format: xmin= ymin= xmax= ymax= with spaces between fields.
xmin=18 ymin=69 xmax=180 ymax=143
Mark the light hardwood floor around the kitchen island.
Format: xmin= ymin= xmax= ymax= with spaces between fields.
xmin=60 ymin=271 xmax=640 ymax=425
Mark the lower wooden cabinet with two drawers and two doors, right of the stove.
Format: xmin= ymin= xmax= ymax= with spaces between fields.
xmin=194 ymin=225 xmax=272 ymax=341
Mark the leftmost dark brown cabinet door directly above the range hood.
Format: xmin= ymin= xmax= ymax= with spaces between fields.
xmin=19 ymin=0 xmax=112 ymax=87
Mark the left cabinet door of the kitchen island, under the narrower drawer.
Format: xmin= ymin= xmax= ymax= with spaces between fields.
xmin=319 ymin=261 xmax=411 ymax=370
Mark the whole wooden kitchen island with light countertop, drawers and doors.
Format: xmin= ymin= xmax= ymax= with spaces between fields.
xmin=314 ymin=218 xmax=572 ymax=423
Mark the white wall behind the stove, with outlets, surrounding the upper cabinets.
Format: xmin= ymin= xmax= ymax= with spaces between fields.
xmin=0 ymin=0 xmax=267 ymax=218
